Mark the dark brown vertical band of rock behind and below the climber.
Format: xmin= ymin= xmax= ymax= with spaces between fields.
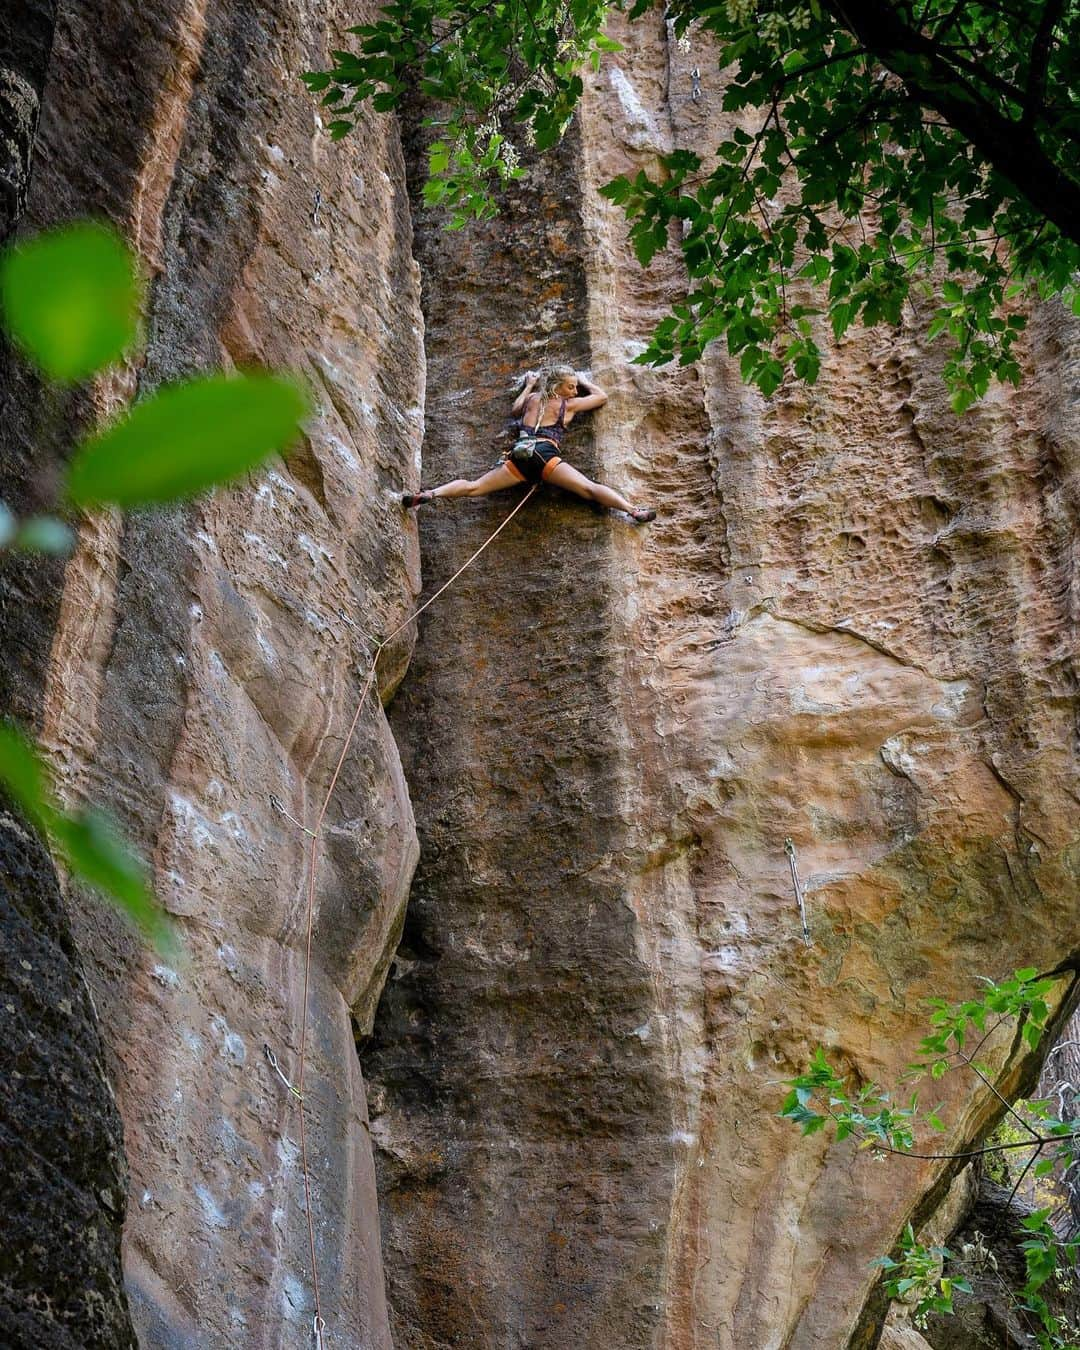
xmin=363 ymin=113 xmax=678 ymax=1350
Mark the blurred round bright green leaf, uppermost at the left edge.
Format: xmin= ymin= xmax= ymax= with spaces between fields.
xmin=0 ymin=224 xmax=140 ymax=382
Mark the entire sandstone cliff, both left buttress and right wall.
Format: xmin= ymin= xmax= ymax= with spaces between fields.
xmin=4 ymin=0 xmax=1080 ymax=1350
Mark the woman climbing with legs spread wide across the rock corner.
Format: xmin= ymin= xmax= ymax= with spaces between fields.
xmin=402 ymin=366 xmax=656 ymax=522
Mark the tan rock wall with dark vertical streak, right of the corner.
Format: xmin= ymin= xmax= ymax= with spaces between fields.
xmin=363 ymin=18 xmax=1080 ymax=1350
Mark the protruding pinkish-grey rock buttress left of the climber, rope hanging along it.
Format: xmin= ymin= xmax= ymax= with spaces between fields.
xmin=5 ymin=0 xmax=423 ymax=1347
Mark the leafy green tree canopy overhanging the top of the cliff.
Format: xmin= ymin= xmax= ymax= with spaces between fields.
xmin=304 ymin=0 xmax=1080 ymax=410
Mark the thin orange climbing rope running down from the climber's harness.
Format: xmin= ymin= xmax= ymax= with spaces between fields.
xmin=276 ymin=483 xmax=539 ymax=1350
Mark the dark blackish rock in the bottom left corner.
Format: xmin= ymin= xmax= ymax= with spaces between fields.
xmin=0 ymin=813 xmax=135 ymax=1350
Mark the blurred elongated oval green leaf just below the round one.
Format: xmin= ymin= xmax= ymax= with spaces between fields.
xmin=66 ymin=374 xmax=308 ymax=506
